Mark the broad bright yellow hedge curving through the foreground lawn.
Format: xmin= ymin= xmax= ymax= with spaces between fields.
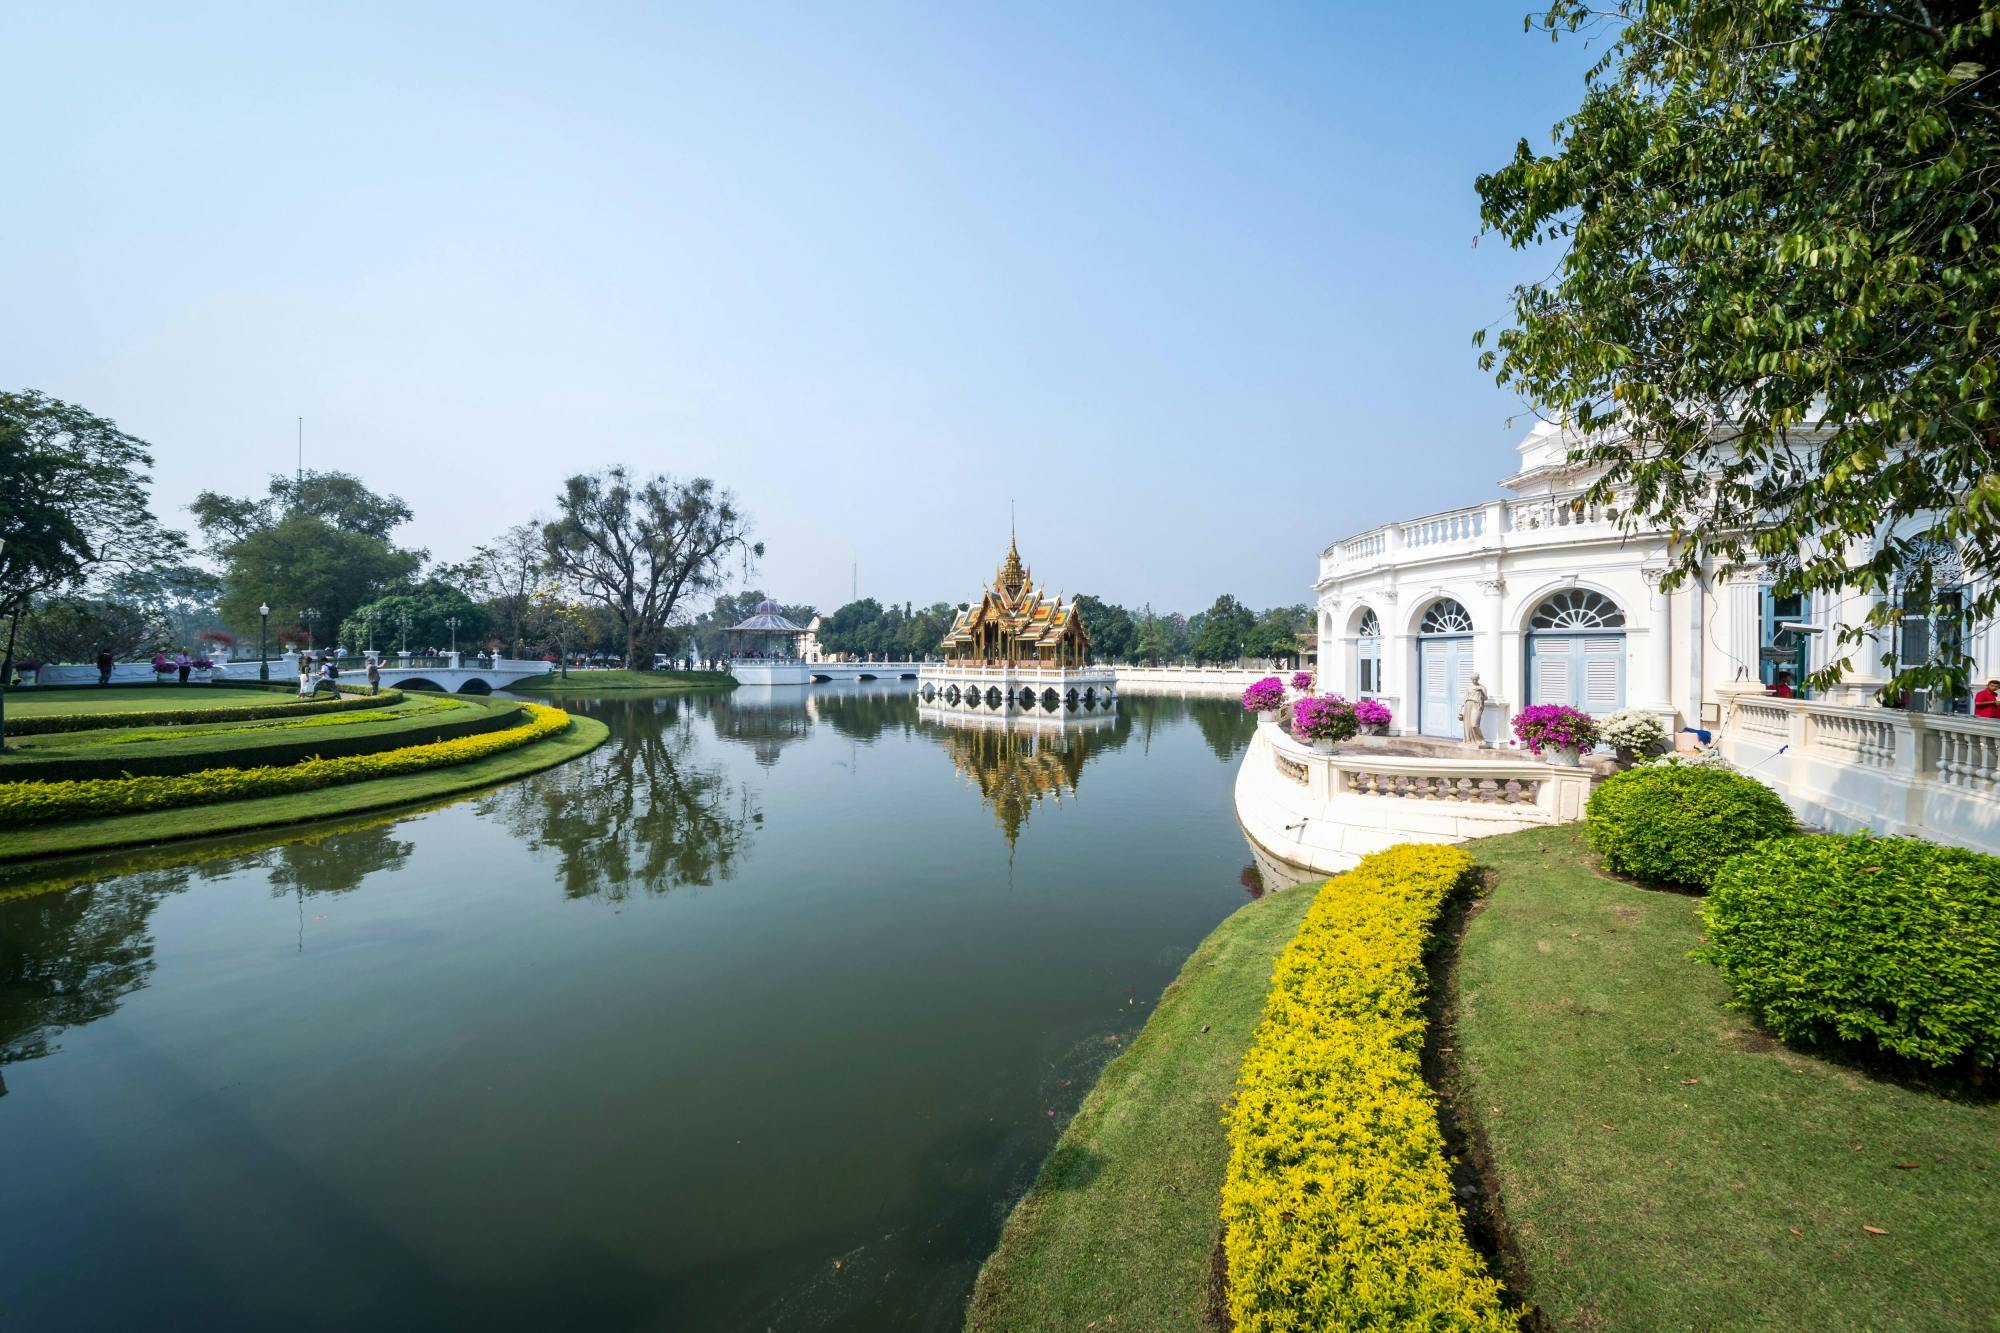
xmin=1222 ymin=845 xmax=1518 ymax=1333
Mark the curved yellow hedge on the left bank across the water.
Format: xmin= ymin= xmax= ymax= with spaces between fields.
xmin=0 ymin=705 xmax=570 ymax=825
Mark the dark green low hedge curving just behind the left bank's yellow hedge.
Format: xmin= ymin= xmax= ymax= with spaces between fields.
xmin=0 ymin=699 xmax=520 ymax=783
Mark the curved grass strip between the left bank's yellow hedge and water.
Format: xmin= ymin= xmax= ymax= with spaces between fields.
xmin=0 ymin=715 xmax=610 ymax=868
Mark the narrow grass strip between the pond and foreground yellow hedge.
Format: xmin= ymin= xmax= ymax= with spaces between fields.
xmin=966 ymin=887 xmax=1314 ymax=1333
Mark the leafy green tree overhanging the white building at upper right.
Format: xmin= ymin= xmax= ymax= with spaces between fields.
xmin=1476 ymin=0 xmax=2000 ymax=689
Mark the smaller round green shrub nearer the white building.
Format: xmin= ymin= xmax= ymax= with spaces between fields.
xmin=1584 ymin=765 xmax=1798 ymax=889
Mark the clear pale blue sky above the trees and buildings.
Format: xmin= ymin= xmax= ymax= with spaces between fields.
xmin=0 ymin=0 xmax=1596 ymax=612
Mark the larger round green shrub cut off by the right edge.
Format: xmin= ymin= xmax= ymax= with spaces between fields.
xmin=1696 ymin=835 xmax=2000 ymax=1069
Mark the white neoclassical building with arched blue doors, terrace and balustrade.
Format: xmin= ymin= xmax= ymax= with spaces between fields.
xmin=1236 ymin=424 xmax=2000 ymax=873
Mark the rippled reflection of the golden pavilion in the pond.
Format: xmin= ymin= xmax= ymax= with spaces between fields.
xmin=916 ymin=703 xmax=1116 ymax=847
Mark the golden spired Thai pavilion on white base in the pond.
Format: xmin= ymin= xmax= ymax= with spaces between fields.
xmin=918 ymin=540 xmax=1116 ymax=715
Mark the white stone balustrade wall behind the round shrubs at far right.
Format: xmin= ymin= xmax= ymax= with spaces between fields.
xmin=1722 ymin=695 xmax=2000 ymax=853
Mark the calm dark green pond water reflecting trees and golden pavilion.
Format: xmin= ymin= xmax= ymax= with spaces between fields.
xmin=0 ymin=685 xmax=1256 ymax=1333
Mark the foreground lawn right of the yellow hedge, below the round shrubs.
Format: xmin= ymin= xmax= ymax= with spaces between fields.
xmin=1454 ymin=825 xmax=2000 ymax=1333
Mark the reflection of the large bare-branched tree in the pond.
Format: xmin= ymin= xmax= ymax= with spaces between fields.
xmin=478 ymin=697 xmax=764 ymax=903
